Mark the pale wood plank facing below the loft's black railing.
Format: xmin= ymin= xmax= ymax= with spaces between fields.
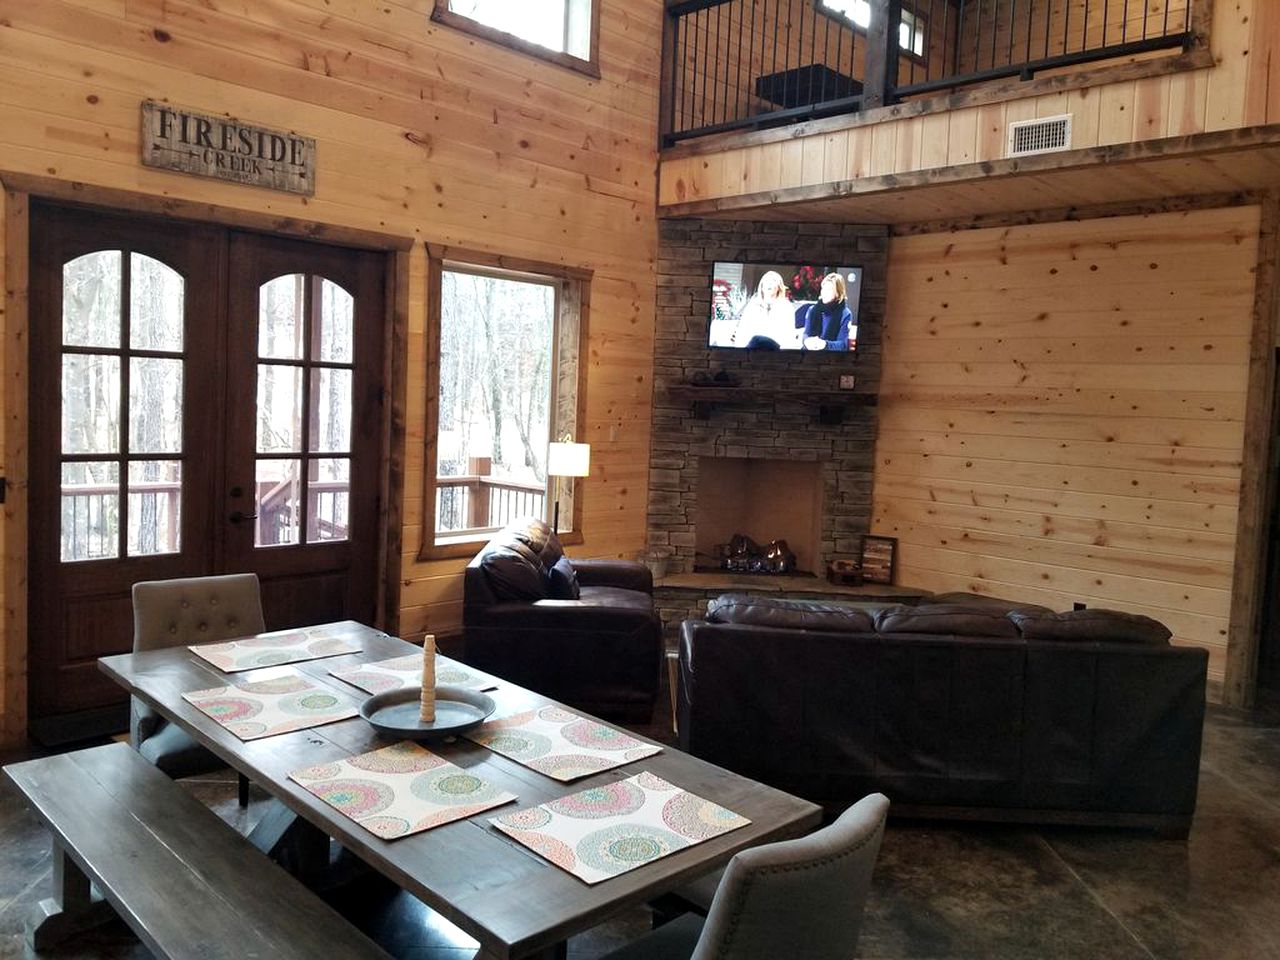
xmin=658 ymin=0 xmax=1280 ymax=206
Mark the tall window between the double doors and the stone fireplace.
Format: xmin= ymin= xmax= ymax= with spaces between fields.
xmin=422 ymin=257 xmax=585 ymax=558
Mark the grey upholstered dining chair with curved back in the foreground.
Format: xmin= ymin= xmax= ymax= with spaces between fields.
xmin=605 ymin=794 xmax=888 ymax=960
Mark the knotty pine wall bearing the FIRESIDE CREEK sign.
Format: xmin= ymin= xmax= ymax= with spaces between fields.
xmin=0 ymin=0 xmax=663 ymax=735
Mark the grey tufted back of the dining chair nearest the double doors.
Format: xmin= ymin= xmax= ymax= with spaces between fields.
xmin=133 ymin=573 xmax=265 ymax=653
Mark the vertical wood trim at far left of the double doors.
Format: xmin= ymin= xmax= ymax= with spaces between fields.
xmin=0 ymin=189 xmax=29 ymax=746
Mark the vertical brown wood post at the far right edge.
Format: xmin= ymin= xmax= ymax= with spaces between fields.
xmin=1222 ymin=191 xmax=1280 ymax=709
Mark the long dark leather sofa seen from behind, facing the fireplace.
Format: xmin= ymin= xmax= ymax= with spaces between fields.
xmin=677 ymin=594 xmax=1208 ymax=836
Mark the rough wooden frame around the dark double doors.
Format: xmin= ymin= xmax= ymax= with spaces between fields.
xmin=0 ymin=170 xmax=415 ymax=748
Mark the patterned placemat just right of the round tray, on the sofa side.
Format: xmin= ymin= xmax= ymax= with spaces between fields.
xmin=463 ymin=707 xmax=662 ymax=783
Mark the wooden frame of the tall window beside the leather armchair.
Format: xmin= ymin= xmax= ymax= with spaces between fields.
xmin=417 ymin=246 xmax=593 ymax=561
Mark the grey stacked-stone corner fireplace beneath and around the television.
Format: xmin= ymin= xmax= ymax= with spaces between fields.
xmin=648 ymin=220 xmax=888 ymax=595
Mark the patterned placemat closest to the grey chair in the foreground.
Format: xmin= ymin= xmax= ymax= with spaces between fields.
xmin=489 ymin=773 xmax=750 ymax=883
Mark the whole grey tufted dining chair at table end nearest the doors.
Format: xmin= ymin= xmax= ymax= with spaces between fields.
xmin=129 ymin=573 xmax=265 ymax=806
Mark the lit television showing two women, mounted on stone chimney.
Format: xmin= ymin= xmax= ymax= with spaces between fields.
xmin=707 ymin=264 xmax=863 ymax=352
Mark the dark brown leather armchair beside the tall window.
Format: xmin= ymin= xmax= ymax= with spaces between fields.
xmin=462 ymin=518 xmax=662 ymax=723
